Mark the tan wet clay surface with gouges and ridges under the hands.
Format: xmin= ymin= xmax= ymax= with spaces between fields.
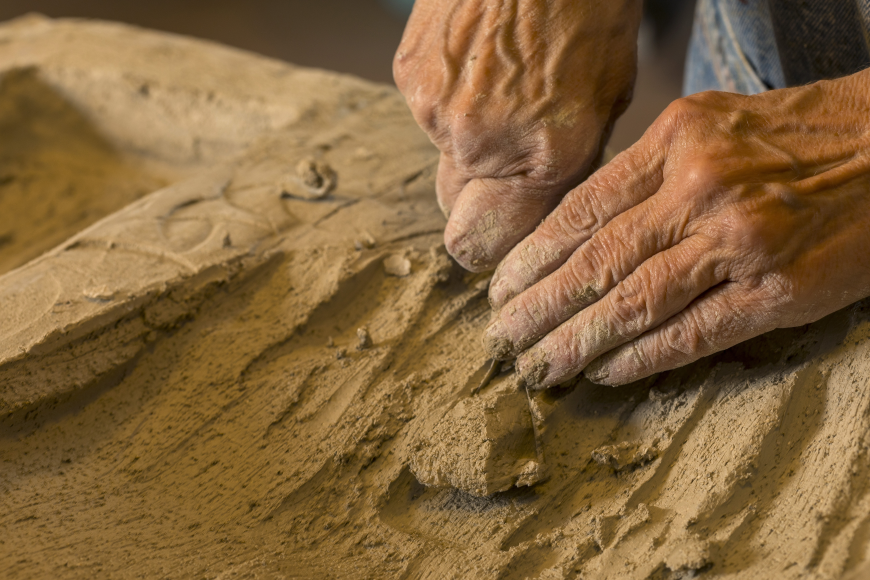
xmin=0 ymin=17 xmax=870 ymax=580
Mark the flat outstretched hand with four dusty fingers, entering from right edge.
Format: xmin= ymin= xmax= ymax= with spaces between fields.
xmin=484 ymin=71 xmax=870 ymax=387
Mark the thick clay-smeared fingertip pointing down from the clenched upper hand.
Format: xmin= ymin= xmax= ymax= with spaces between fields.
xmin=444 ymin=175 xmax=567 ymax=272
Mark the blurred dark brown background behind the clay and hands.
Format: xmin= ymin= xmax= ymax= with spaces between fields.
xmin=0 ymin=0 xmax=693 ymax=150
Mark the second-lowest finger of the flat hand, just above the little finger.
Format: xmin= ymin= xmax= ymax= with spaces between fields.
xmin=517 ymin=235 xmax=727 ymax=388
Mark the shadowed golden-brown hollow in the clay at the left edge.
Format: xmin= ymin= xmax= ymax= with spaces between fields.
xmin=0 ymin=68 xmax=164 ymax=274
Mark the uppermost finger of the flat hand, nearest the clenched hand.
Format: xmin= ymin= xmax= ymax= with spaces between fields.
xmin=489 ymin=135 xmax=665 ymax=309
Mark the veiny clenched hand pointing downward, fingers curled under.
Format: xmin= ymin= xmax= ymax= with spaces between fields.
xmin=393 ymin=0 xmax=641 ymax=271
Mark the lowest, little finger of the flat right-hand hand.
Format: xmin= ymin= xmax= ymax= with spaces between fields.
xmin=584 ymin=283 xmax=776 ymax=385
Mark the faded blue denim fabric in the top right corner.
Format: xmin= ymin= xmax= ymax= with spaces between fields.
xmin=683 ymin=0 xmax=870 ymax=95
